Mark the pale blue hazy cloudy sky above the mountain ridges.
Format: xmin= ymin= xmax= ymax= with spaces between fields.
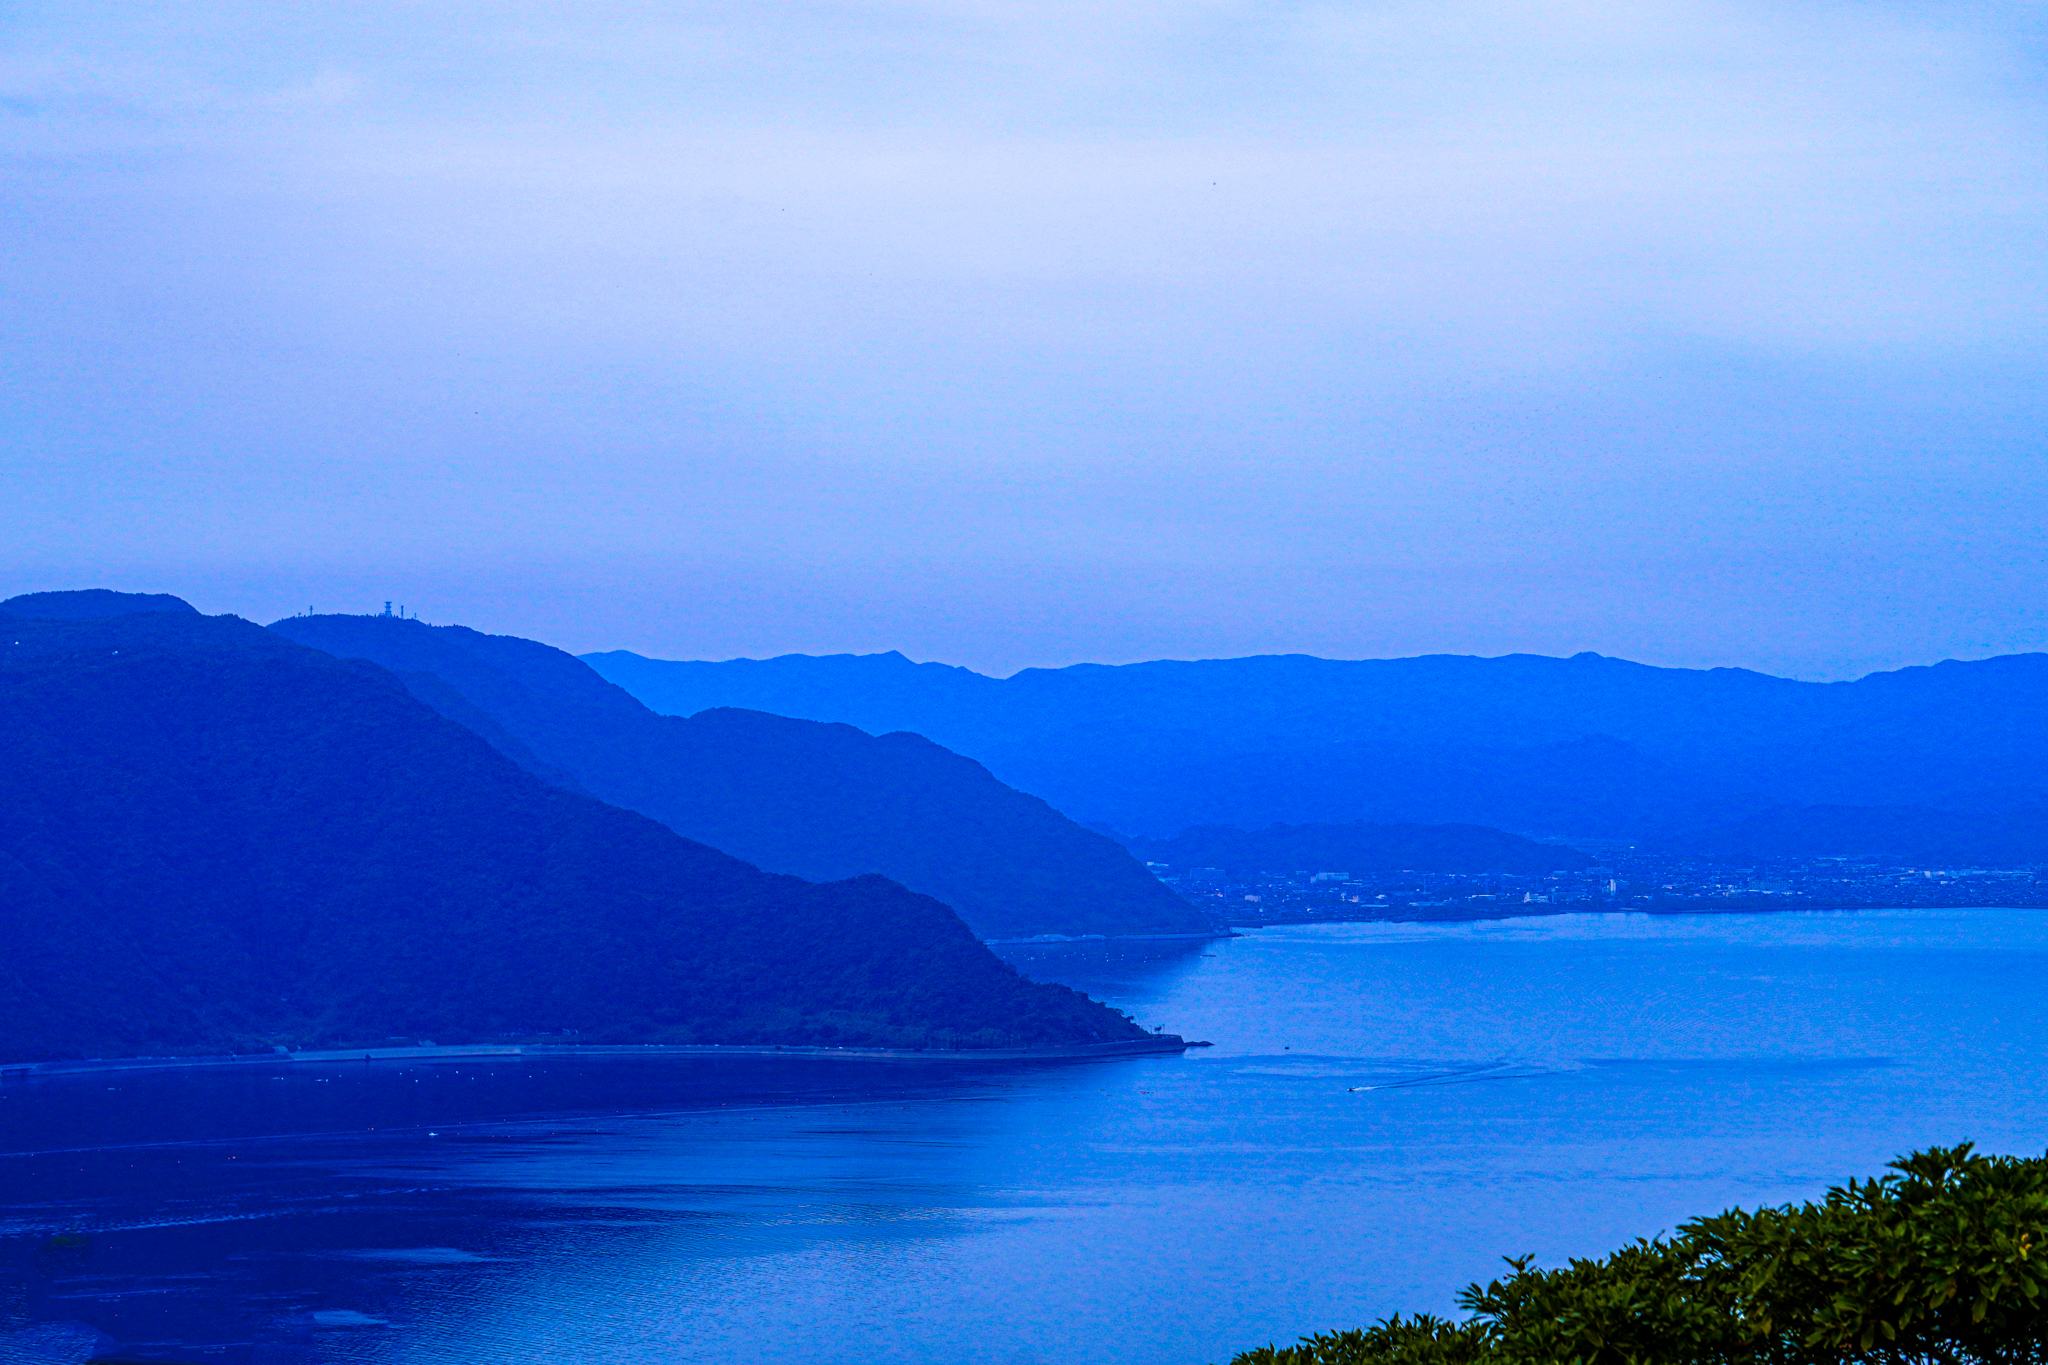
xmin=0 ymin=0 xmax=2048 ymax=677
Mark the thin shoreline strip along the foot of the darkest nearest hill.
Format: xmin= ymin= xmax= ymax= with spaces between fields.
xmin=0 ymin=1033 xmax=1206 ymax=1081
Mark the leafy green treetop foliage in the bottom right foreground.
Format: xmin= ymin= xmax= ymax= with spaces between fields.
xmin=1233 ymin=1144 xmax=2048 ymax=1365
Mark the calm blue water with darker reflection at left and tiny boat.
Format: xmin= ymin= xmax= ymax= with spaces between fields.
xmin=0 ymin=911 xmax=2048 ymax=1365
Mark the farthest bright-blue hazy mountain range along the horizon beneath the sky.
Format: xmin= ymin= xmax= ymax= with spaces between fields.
xmin=586 ymin=651 xmax=2048 ymax=839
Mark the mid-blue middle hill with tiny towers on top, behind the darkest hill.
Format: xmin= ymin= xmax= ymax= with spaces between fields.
xmin=270 ymin=616 xmax=1210 ymax=937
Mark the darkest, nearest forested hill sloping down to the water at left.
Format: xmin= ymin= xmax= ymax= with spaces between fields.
xmin=0 ymin=612 xmax=1137 ymax=1058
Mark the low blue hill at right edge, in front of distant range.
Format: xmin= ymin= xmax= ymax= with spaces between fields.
xmin=1651 ymin=806 xmax=2048 ymax=868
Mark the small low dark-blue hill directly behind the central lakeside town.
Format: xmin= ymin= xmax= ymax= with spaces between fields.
xmin=1124 ymin=821 xmax=1593 ymax=874
